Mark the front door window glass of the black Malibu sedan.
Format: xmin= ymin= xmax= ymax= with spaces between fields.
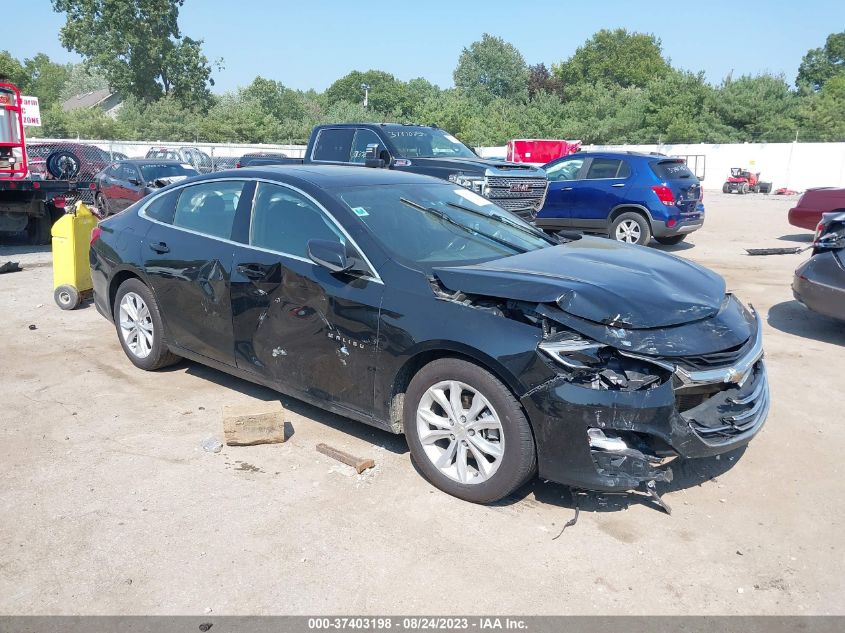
xmin=249 ymin=182 xmax=346 ymax=258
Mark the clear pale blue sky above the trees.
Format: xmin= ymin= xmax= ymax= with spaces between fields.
xmin=6 ymin=0 xmax=845 ymax=92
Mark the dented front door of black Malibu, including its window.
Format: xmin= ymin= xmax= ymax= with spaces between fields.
xmin=232 ymin=182 xmax=384 ymax=415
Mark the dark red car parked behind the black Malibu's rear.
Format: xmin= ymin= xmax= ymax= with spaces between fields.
xmin=94 ymin=159 xmax=199 ymax=217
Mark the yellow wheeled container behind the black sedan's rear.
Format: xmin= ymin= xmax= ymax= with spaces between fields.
xmin=52 ymin=202 xmax=97 ymax=310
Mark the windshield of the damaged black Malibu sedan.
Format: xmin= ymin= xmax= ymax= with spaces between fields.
xmin=332 ymin=183 xmax=557 ymax=272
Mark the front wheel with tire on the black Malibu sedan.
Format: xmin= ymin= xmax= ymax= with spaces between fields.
xmin=403 ymin=358 xmax=537 ymax=503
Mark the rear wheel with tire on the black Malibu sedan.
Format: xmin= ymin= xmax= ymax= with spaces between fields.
xmin=112 ymin=278 xmax=179 ymax=371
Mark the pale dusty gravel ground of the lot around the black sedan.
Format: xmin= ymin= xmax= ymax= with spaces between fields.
xmin=0 ymin=192 xmax=845 ymax=615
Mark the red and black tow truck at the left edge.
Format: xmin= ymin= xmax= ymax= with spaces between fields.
xmin=0 ymin=83 xmax=96 ymax=244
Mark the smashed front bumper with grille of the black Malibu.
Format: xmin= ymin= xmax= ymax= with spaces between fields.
xmin=522 ymin=318 xmax=769 ymax=492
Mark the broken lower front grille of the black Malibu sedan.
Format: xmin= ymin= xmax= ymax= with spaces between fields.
xmin=675 ymin=361 xmax=769 ymax=445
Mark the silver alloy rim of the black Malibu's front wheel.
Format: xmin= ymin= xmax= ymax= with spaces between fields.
xmin=417 ymin=380 xmax=505 ymax=484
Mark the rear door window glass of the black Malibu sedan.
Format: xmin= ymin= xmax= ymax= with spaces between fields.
xmin=173 ymin=180 xmax=244 ymax=240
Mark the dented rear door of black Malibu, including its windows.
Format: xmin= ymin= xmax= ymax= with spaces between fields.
xmin=141 ymin=180 xmax=249 ymax=365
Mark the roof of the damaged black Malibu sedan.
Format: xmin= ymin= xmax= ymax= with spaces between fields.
xmin=194 ymin=165 xmax=448 ymax=188
